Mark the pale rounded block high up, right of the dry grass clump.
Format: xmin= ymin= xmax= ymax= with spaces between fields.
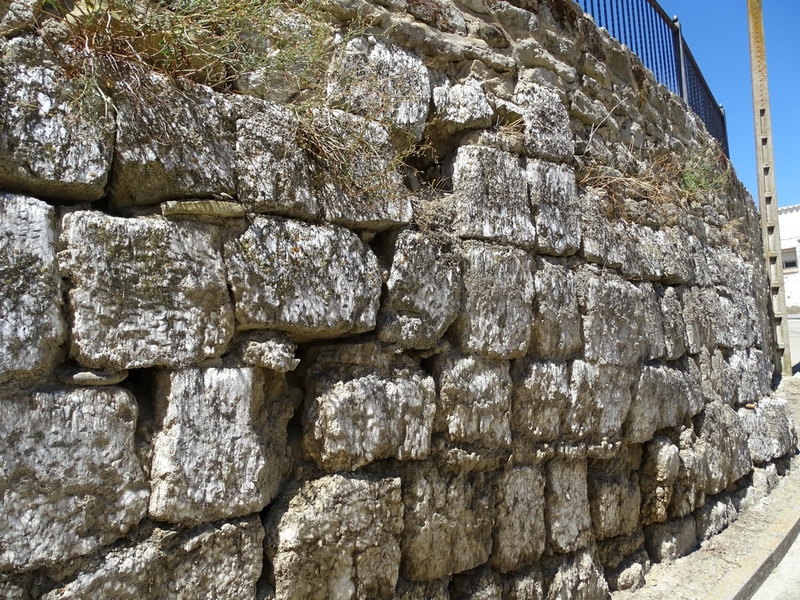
xmin=328 ymin=36 xmax=431 ymax=143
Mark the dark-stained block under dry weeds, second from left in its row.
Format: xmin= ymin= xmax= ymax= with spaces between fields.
xmin=109 ymin=72 xmax=236 ymax=207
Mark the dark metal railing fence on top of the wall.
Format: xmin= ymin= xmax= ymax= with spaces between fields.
xmin=577 ymin=0 xmax=728 ymax=155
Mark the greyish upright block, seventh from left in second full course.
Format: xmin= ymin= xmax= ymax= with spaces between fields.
xmin=576 ymin=268 xmax=645 ymax=366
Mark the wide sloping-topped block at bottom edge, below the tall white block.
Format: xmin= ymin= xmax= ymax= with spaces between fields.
xmin=42 ymin=516 xmax=264 ymax=600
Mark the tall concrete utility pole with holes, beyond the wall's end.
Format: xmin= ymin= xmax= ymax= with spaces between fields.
xmin=747 ymin=0 xmax=792 ymax=376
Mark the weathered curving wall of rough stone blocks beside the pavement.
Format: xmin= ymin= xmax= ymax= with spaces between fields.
xmin=0 ymin=0 xmax=796 ymax=600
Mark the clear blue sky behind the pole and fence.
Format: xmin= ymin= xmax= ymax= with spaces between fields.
xmin=659 ymin=0 xmax=800 ymax=206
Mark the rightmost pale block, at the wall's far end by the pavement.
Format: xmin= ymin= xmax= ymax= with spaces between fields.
xmin=738 ymin=398 xmax=796 ymax=464
